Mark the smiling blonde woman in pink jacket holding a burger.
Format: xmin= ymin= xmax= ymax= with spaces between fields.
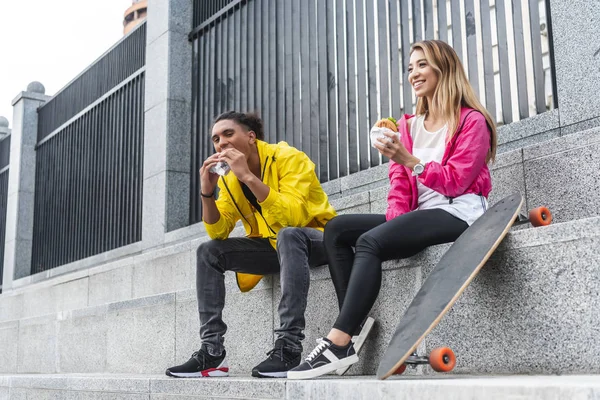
xmin=288 ymin=40 xmax=496 ymax=379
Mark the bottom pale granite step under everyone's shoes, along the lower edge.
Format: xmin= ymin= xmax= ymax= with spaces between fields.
xmin=0 ymin=374 xmax=600 ymax=400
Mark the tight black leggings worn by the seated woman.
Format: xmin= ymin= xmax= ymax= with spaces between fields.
xmin=324 ymin=209 xmax=468 ymax=335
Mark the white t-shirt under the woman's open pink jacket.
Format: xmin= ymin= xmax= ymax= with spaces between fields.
xmin=410 ymin=115 xmax=488 ymax=225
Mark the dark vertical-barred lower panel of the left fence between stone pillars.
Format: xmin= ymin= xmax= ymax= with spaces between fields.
xmin=31 ymin=72 xmax=144 ymax=274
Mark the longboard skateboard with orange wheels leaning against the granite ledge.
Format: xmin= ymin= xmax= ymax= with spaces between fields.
xmin=377 ymin=193 xmax=552 ymax=379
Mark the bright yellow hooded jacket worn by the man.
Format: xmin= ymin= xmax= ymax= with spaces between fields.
xmin=204 ymin=140 xmax=335 ymax=292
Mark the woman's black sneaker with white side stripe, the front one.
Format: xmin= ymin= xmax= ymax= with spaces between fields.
xmin=287 ymin=338 xmax=358 ymax=379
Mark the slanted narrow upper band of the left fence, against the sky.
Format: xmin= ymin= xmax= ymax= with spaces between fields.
xmin=38 ymin=22 xmax=146 ymax=142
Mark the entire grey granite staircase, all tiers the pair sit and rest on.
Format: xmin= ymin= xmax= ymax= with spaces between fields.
xmin=0 ymin=128 xmax=600 ymax=399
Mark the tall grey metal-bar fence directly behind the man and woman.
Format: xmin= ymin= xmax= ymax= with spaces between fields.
xmin=190 ymin=0 xmax=556 ymax=223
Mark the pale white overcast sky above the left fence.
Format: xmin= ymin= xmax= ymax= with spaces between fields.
xmin=0 ymin=0 xmax=132 ymax=128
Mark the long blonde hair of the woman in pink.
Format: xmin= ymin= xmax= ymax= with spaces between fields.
xmin=410 ymin=40 xmax=497 ymax=162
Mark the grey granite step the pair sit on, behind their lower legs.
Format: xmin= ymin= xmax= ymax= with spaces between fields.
xmin=0 ymin=217 xmax=600 ymax=375
